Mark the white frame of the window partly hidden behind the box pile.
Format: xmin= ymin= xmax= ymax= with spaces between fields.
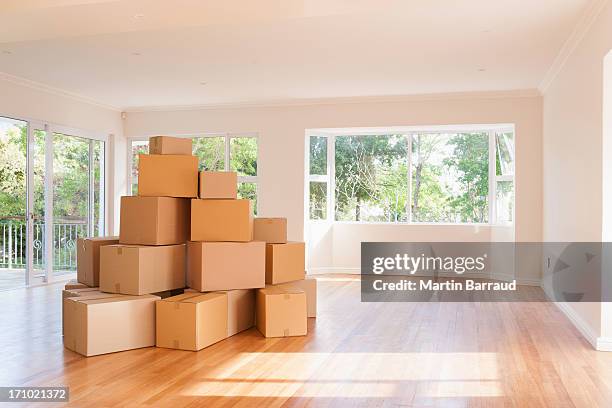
xmin=126 ymin=132 xmax=260 ymax=213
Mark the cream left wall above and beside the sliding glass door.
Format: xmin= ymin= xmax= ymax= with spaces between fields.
xmin=0 ymin=74 xmax=126 ymax=232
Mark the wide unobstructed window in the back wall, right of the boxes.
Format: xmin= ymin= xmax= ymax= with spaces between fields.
xmin=308 ymin=127 xmax=514 ymax=224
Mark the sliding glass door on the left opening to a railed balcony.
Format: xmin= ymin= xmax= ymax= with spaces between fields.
xmin=0 ymin=118 xmax=106 ymax=290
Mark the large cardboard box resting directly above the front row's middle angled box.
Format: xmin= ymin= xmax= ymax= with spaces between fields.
xmin=187 ymin=241 xmax=266 ymax=292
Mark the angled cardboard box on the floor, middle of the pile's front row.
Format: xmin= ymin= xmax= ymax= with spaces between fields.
xmin=155 ymin=292 xmax=228 ymax=351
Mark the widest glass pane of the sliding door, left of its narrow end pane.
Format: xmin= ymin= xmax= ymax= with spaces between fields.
xmin=53 ymin=133 xmax=93 ymax=275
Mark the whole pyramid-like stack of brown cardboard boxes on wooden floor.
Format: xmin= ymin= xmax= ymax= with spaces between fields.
xmin=63 ymin=136 xmax=316 ymax=356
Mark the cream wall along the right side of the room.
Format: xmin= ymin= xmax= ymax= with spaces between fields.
xmin=543 ymin=2 xmax=612 ymax=345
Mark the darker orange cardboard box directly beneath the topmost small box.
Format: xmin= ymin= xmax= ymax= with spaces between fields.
xmin=138 ymin=154 xmax=198 ymax=198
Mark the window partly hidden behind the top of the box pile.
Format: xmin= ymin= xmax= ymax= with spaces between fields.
xmin=129 ymin=134 xmax=258 ymax=215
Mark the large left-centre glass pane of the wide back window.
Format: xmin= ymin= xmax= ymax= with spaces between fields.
xmin=335 ymin=135 xmax=408 ymax=222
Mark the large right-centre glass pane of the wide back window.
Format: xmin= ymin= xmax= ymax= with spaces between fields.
xmin=411 ymin=133 xmax=489 ymax=223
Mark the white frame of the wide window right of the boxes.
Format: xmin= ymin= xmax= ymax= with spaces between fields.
xmin=304 ymin=124 xmax=516 ymax=226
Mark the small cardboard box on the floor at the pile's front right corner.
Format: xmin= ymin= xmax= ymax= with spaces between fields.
xmin=257 ymin=287 xmax=307 ymax=337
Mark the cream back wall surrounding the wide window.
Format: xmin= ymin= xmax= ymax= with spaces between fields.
xmin=124 ymin=93 xmax=542 ymax=277
